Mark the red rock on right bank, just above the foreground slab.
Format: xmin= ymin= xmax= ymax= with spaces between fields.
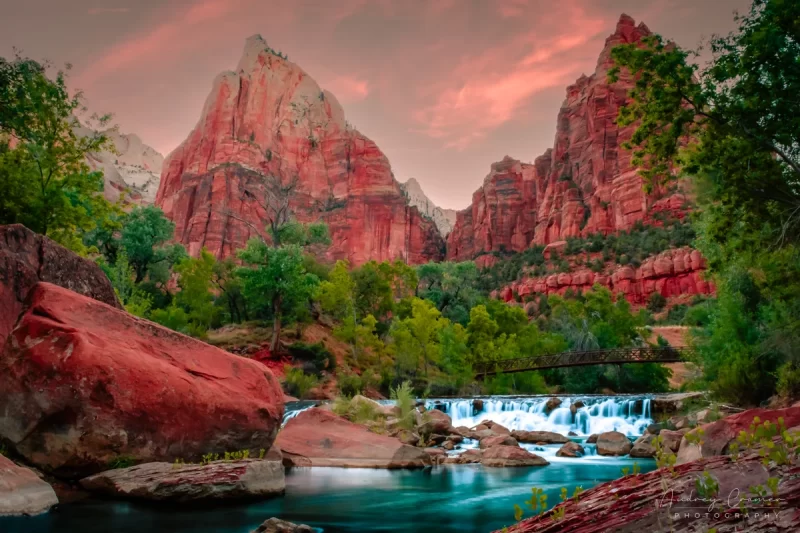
xmin=678 ymin=407 xmax=800 ymax=464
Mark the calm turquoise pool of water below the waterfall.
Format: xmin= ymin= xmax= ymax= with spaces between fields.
xmin=6 ymin=454 xmax=655 ymax=533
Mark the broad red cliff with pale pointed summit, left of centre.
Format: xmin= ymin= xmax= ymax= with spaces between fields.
xmin=156 ymin=36 xmax=444 ymax=264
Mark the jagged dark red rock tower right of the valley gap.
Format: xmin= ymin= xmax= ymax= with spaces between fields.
xmin=447 ymin=15 xmax=685 ymax=260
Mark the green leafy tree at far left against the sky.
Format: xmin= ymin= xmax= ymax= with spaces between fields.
xmin=0 ymin=56 xmax=118 ymax=253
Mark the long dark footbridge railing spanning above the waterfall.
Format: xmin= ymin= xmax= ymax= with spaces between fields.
xmin=474 ymin=346 xmax=692 ymax=376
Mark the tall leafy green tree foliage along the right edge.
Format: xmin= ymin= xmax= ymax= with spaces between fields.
xmin=610 ymin=0 xmax=800 ymax=405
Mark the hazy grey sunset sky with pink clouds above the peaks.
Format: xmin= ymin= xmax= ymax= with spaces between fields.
xmin=0 ymin=0 xmax=750 ymax=209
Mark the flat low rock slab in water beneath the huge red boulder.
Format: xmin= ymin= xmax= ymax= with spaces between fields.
xmin=80 ymin=459 xmax=285 ymax=503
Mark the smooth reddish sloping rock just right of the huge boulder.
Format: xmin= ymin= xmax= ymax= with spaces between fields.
xmin=276 ymin=407 xmax=431 ymax=468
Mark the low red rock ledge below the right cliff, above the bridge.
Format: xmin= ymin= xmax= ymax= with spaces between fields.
xmin=498 ymin=248 xmax=715 ymax=305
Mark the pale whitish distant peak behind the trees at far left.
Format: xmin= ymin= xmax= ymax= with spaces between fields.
xmin=76 ymin=127 xmax=164 ymax=205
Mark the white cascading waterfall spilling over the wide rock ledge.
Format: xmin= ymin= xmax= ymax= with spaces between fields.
xmin=425 ymin=396 xmax=653 ymax=437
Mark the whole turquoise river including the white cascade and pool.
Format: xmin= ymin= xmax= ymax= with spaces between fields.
xmin=0 ymin=396 xmax=655 ymax=533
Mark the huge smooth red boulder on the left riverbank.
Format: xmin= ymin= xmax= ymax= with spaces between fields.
xmin=0 ymin=283 xmax=283 ymax=477
